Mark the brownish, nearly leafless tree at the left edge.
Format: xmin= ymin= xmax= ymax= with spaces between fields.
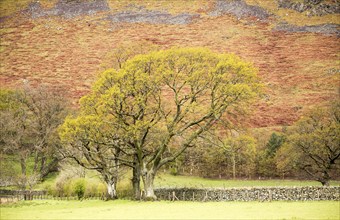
xmin=0 ymin=84 xmax=66 ymax=188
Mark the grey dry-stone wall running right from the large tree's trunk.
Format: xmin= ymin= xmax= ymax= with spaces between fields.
xmin=155 ymin=186 xmax=340 ymax=201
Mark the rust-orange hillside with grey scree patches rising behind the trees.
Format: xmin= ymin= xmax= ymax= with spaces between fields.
xmin=0 ymin=0 xmax=340 ymax=127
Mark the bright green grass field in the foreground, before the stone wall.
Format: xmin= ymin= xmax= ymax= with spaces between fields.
xmin=1 ymin=200 xmax=340 ymax=219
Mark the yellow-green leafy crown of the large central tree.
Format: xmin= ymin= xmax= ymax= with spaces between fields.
xmin=67 ymin=48 xmax=262 ymax=145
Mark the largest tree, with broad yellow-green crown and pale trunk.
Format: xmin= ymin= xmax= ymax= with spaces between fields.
xmin=60 ymin=48 xmax=261 ymax=199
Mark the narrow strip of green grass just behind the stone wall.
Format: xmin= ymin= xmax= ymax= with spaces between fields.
xmin=155 ymin=174 xmax=340 ymax=187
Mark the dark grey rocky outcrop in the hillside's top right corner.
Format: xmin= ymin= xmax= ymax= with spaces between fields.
xmin=278 ymin=0 xmax=340 ymax=16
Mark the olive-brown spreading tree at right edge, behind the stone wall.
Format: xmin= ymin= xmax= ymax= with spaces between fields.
xmin=277 ymin=102 xmax=340 ymax=186
